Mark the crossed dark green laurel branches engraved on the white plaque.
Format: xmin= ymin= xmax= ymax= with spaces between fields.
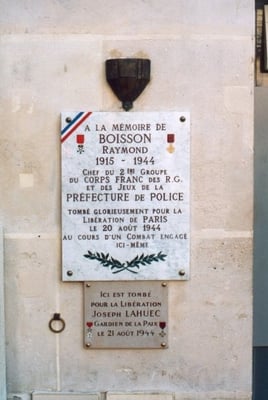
xmin=84 ymin=250 xmax=167 ymax=274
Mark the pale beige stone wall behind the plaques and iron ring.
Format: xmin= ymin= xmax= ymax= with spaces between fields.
xmin=0 ymin=0 xmax=254 ymax=400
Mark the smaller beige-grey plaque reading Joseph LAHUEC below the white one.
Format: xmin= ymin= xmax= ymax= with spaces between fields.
xmin=84 ymin=281 xmax=168 ymax=349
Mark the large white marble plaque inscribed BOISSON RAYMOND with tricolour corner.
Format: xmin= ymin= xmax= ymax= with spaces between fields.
xmin=61 ymin=112 xmax=190 ymax=281
